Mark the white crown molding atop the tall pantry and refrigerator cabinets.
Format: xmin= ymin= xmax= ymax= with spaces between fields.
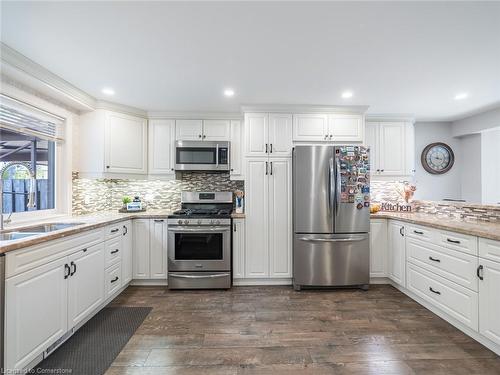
xmin=241 ymin=104 xmax=368 ymax=114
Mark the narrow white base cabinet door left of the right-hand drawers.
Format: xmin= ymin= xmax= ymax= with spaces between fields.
xmin=387 ymin=220 xmax=406 ymax=287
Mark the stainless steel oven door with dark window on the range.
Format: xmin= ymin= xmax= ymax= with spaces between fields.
xmin=168 ymin=226 xmax=231 ymax=271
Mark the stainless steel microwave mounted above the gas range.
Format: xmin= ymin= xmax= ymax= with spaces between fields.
xmin=175 ymin=141 xmax=229 ymax=171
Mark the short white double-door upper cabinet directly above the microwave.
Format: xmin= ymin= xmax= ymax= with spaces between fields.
xmin=175 ymin=120 xmax=231 ymax=141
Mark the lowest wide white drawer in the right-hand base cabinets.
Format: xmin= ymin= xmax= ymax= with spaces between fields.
xmin=407 ymin=264 xmax=478 ymax=331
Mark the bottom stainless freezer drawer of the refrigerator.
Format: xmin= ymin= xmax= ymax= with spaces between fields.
xmin=293 ymin=233 xmax=370 ymax=287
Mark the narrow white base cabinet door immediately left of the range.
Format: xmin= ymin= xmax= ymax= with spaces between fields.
xmin=149 ymin=219 xmax=167 ymax=279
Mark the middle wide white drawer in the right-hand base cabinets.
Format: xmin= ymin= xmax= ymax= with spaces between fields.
xmin=406 ymin=238 xmax=478 ymax=291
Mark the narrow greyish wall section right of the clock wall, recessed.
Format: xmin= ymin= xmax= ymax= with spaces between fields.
xmin=460 ymin=134 xmax=481 ymax=203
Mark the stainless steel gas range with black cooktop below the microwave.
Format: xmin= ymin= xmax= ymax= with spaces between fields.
xmin=168 ymin=192 xmax=233 ymax=289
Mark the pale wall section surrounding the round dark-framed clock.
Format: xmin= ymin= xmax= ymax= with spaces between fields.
xmin=415 ymin=122 xmax=462 ymax=201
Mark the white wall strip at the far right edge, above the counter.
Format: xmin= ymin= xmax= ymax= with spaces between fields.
xmin=481 ymin=127 xmax=500 ymax=204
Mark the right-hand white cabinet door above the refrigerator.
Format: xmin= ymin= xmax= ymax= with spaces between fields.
xmin=328 ymin=115 xmax=364 ymax=143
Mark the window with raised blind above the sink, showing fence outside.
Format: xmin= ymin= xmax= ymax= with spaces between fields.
xmin=0 ymin=128 xmax=55 ymax=213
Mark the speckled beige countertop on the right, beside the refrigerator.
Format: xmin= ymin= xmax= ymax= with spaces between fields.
xmin=371 ymin=212 xmax=500 ymax=241
